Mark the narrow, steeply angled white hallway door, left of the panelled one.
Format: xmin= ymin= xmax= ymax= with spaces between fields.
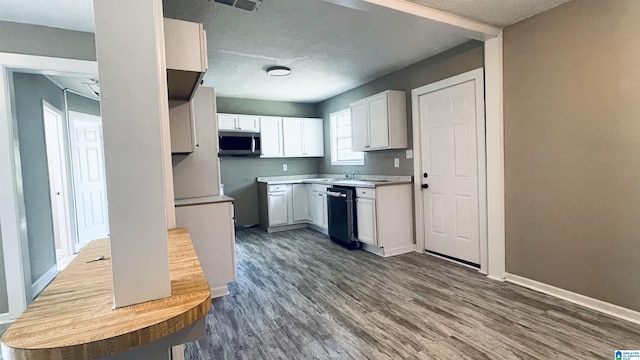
xmin=42 ymin=102 xmax=73 ymax=256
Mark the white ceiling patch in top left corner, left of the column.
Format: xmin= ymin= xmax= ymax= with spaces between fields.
xmin=0 ymin=0 xmax=94 ymax=32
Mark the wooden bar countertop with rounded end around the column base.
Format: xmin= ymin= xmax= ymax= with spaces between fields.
xmin=2 ymin=228 xmax=211 ymax=360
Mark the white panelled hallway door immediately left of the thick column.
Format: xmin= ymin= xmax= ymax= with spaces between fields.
xmin=69 ymin=112 xmax=109 ymax=250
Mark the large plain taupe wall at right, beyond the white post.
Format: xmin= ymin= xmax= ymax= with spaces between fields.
xmin=504 ymin=0 xmax=640 ymax=311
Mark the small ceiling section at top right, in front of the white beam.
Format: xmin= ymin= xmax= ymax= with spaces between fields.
xmin=408 ymin=0 xmax=569 ymax=27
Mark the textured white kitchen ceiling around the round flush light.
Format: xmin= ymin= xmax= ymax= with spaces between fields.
xmin=164 ymin=0 xmax=468 ymax=102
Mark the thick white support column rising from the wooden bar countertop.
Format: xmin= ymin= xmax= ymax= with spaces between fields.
xmin=94 ymin=0 xmax=173 ymax=308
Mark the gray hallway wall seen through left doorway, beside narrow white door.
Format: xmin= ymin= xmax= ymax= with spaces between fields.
xmin=13 ymin=73 xmax=63 ymax=283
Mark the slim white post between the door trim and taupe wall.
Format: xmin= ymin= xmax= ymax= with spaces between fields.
xmin=484 ymin=33 xmax=505 ymax=280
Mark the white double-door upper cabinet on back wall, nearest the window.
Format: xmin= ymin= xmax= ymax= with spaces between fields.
xmin=282 ymin=118 xmax=324 ymax=157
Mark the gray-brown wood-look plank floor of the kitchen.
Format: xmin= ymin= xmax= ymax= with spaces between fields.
xmin=185 ymin=229 xmax=640 ymax=360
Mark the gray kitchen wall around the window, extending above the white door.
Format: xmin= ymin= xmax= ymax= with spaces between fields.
xmin=318 ymin=41 xmax=484 ymax=175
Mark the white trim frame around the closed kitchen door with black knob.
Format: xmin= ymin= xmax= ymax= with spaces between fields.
xmin=411 ymin=68 xmax=488 ymax=274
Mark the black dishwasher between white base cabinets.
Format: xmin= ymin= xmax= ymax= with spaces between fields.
xmin=327 ymin=185 xmax=360 ymax=249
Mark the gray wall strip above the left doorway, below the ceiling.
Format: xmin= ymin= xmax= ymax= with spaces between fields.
xmin=0 ymin=21 xmax=96 ymax=60
